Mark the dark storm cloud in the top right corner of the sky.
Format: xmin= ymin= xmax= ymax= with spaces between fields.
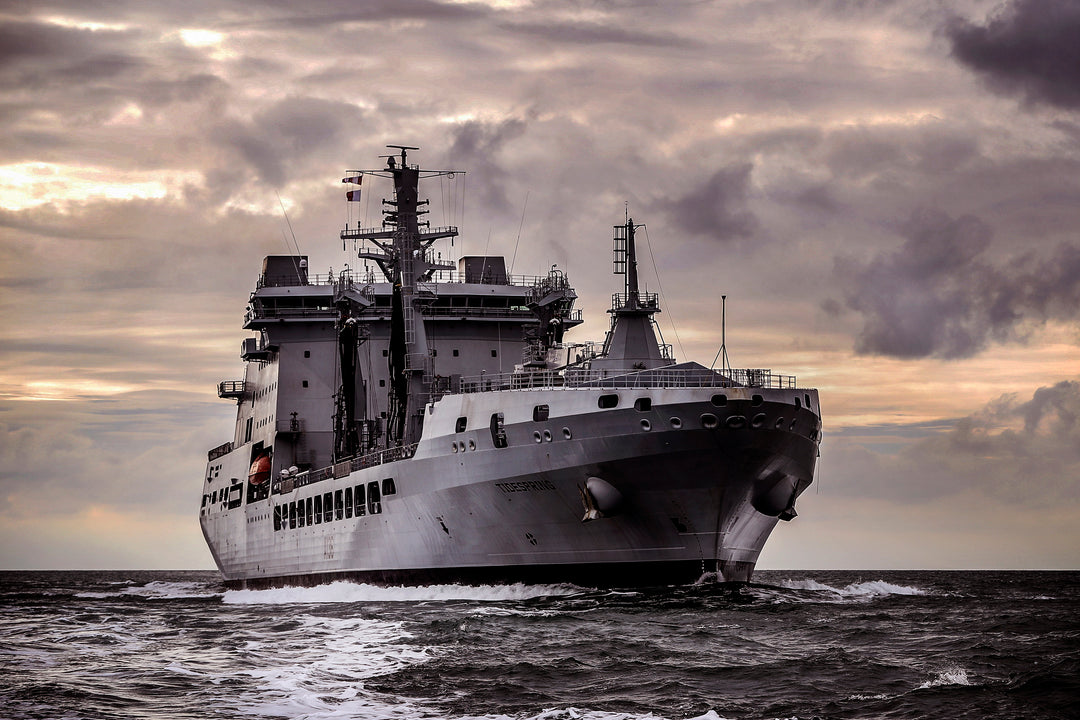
xmin=946 ymin=0 xmax=1080 ymax=109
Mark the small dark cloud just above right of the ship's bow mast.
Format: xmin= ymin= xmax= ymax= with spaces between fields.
xmin=658 ymin=163 xmax=758 ymax=242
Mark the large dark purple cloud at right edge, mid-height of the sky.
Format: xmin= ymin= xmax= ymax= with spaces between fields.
xmin=825 ymin=210 xmax=1080 ymax=358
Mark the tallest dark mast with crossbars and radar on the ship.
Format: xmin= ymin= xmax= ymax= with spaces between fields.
xmin=341 ymin=145 xmax=458 ymax=447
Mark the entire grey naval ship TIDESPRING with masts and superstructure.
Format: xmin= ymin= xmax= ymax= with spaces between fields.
xmin=200 ymin=146 xmax=821 ymax=587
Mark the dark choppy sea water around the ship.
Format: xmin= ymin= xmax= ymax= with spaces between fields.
xmin=0 ymin=571 xmax=1080 ymax=720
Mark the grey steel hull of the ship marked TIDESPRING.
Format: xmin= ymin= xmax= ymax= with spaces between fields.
xmin=202 ymin=388 xmax=820 ymax=587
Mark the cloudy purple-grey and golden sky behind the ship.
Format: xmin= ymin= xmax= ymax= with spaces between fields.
xmin=0 ymin=0 xmax=1080 ymax=569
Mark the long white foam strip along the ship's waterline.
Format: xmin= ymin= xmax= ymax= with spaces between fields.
xmin=224 ymin=582 xmax=581 ymax=604
